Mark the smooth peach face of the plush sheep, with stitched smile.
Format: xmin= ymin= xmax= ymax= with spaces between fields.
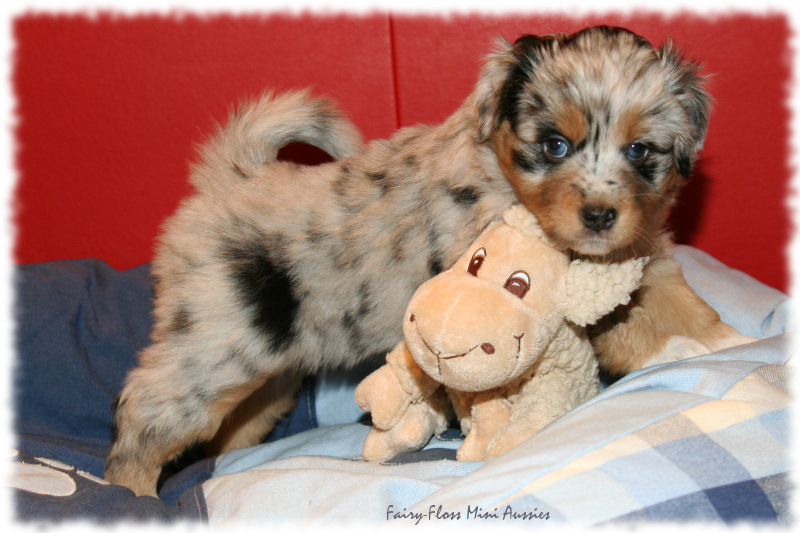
xmin=403 ymin=220 xmax=569 ymax=392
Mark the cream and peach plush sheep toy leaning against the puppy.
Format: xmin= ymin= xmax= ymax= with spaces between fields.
xmin=356 ymin=206 xmax=647 ymax=461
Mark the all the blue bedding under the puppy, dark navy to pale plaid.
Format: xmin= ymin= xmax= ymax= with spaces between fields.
xmin=9 ymin=247 xmax=792 ymax=525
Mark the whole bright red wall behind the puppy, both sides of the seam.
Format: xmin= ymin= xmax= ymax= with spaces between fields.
xmin=13 ymin=14 xmax=790 ymax=290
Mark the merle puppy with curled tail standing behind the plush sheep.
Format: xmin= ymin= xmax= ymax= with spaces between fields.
xmin=105 ymin=27 xmax=742 ymax=495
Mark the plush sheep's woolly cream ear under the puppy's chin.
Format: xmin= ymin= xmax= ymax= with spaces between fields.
xmin=565 ymin=257 xmax=648 ymax=326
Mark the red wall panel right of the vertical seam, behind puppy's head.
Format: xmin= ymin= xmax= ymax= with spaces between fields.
xmin=392 ymin=15 xmax=790 ymax=290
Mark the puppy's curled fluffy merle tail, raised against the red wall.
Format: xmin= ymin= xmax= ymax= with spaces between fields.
xmin=191 ymin=90 xmax=363 ymax=192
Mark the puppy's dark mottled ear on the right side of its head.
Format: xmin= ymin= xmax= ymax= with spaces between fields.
xmin=658 ymin=41 xmax=712 ymax=178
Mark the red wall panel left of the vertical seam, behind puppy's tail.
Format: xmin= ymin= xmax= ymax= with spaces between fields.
xmin=13 ymin=15 xmax=396 ymax=268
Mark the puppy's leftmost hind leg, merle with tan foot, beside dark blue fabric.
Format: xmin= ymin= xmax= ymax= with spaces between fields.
xmin=105 ymin=343 xmax=277 ymax=496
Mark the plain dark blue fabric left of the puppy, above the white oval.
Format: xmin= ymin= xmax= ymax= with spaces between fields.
xmin=14 ymin=260 xmax=153 ymax=440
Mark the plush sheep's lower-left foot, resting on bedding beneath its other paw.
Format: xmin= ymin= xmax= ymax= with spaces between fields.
xmin=362 ymin=402 xmax=441 ymax=461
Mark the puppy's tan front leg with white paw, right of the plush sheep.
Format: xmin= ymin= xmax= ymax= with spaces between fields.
xmin=588 ymin=258 xmax=756 ymax=374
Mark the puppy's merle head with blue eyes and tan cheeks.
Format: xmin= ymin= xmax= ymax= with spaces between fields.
xmin=475 ymin=26 xmax=710 ymax=256
